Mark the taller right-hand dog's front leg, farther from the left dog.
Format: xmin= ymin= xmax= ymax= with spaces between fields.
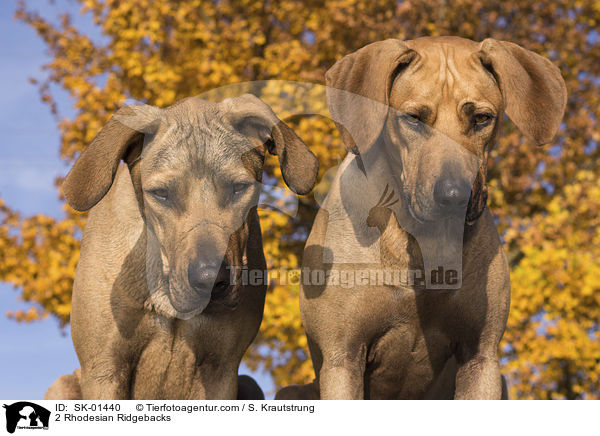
xmin=454 ymin=352 xmax=502 ymax=400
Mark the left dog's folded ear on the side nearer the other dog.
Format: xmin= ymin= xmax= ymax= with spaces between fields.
xmin=222 ymin=94 xmax=319 ymax=195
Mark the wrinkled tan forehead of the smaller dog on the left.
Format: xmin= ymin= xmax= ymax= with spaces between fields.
xmin=142 ymin=98 xmax=252 ymax=172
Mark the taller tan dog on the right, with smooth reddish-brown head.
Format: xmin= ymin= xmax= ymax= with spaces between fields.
xmin=277 ymin=37 xmax=566 ymax=399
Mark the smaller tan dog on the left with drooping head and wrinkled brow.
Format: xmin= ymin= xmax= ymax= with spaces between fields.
xmin=46 ymin=95 xmax=318 ymax=399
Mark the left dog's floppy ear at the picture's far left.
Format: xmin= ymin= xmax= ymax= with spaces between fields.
xmin=62 ymin=106 xmax=160 ymax=211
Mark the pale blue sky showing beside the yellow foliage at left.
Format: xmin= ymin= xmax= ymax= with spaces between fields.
xmin=0 ymin=0 xmax=274 ymax=400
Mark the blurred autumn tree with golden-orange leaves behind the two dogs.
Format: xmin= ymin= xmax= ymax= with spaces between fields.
xmin=0 ymin=0 xmax=600 ymax=398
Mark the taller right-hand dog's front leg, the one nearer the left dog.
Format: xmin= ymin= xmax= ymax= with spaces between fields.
xmin=319 ymin=345 xmax=366 ymax=400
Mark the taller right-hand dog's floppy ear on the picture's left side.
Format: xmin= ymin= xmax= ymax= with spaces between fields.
xmin=325 ymin=39 xmax=418 ymax=154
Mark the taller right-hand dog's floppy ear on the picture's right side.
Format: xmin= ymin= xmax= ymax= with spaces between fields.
xmin=478 ymin=38 xmax=567 ymax=145
